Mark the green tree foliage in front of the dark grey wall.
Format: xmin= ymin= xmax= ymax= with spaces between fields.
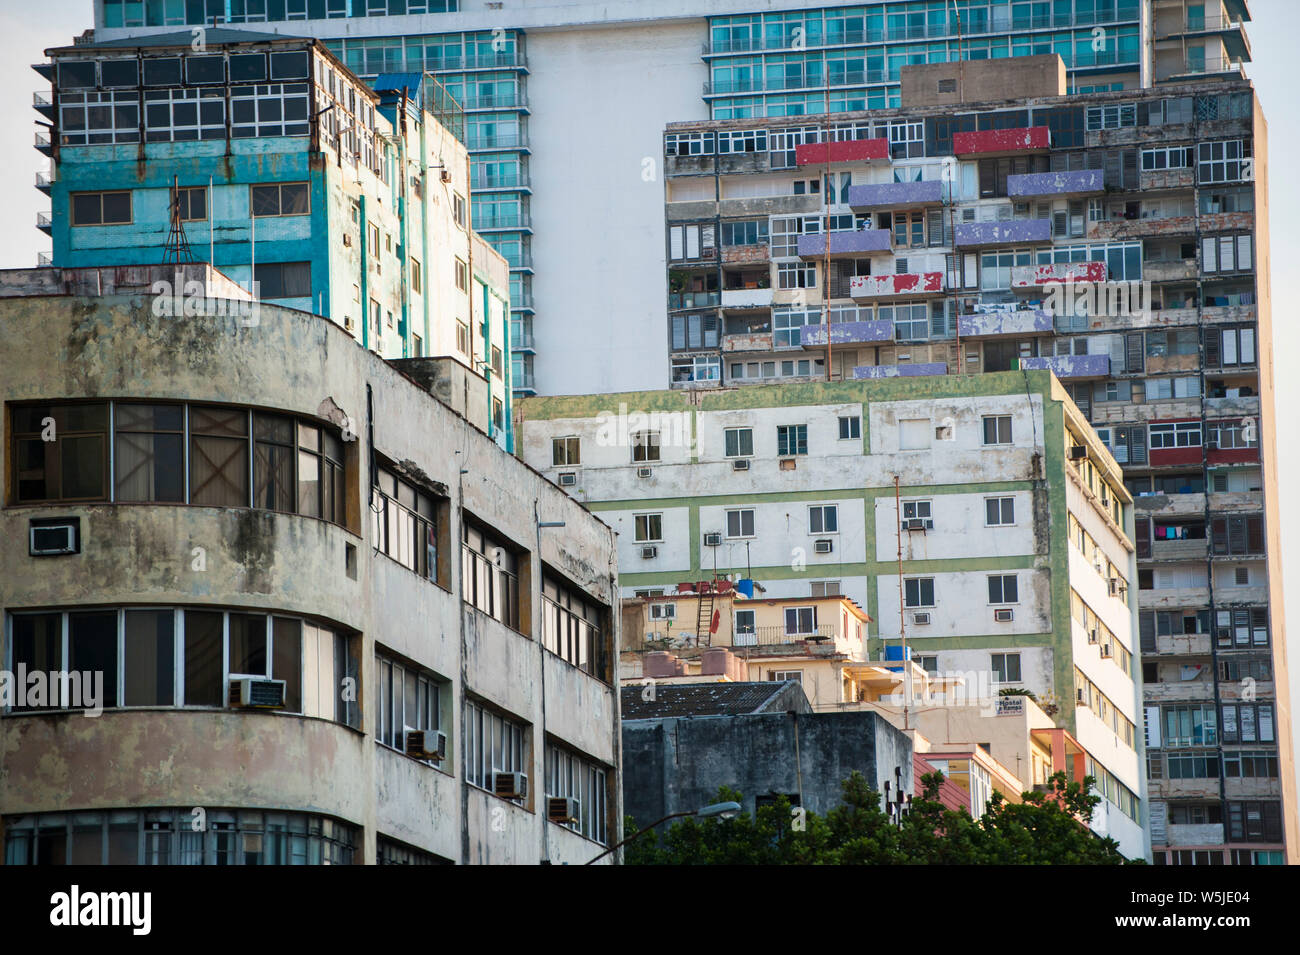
xmin=624 ymin=772 xmax=1127 ymax=865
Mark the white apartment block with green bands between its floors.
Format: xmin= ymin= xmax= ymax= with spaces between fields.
xmin=516 ymin=369 xmax=1143 ymax=847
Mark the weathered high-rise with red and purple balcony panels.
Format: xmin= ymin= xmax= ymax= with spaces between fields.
xmin=650 ymin=57 xmax=1296 ymax=864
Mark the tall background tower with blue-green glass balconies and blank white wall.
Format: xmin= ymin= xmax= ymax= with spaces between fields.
xmin=86 ymin=0 xmax=1249 ymax=394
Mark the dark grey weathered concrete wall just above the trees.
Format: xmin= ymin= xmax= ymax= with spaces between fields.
xmin=623 ymin=712 xmax=913 ymax=825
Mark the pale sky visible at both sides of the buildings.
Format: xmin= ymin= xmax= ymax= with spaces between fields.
xmin=0 ymin=0 xmax=1300 ymax=764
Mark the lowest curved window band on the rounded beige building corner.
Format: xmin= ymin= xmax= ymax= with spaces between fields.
xmin=4 ymin=808 xmax=361 ymax=865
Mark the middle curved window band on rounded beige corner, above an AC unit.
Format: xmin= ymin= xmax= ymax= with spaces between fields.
xmin=9 ymin=607 xmax=360 ymax=726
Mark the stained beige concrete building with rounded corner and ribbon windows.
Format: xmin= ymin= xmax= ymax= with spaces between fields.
xmin=0 ymin=264 xmax=621 ymax=864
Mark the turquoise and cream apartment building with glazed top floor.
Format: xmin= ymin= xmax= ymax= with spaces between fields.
xmin=36 ymin=29 xmax=511 ymax=444
